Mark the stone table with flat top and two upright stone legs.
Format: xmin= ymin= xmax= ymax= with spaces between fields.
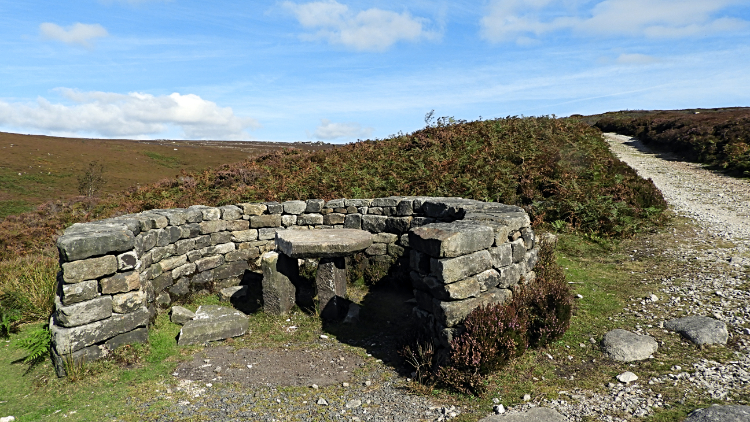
xmin=262 ymin=229 xmax=372 ymax=319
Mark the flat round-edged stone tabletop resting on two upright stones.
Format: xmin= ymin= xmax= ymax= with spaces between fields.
xmin=276 ymin=229 xmax=372 ymax=258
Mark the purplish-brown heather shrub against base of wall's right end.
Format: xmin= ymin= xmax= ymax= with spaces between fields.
xmin=420 ymin=237 xmax=573 ymax=395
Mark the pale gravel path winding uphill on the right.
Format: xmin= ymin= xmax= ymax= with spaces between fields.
xmin=502 ymin=133 xmax=750 ymax=421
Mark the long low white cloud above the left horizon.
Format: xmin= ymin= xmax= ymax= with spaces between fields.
xmin=0 ymin=88 xmax=260 ymax=140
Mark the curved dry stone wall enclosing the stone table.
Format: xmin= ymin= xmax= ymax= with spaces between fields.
xmin=50 ymin=196 xmax=538 ymax=375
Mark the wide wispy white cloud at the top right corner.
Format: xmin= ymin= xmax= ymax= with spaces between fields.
xmin=481 ymin=0 xmax=749 ymax=44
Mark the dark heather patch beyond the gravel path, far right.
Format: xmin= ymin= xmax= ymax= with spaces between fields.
xmin=588 ymin=108 xmax=750 ymax=177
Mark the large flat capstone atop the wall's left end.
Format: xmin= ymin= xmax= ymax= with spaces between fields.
xmin=57 ymin=229 xmax=135 ymax=262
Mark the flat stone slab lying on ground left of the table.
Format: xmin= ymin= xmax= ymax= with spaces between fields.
xmin=177 ymin=305 xmax=249 ymax=346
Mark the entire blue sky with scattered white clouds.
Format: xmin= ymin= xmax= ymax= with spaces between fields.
xmin=0 ymin=0 xmax=750 ymax=143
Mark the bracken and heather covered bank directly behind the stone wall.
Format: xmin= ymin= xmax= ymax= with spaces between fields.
xmin=0 ymin=117 xmax=666 ymax=259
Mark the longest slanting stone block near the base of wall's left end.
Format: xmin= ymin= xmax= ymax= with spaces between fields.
xmin=50 ymin=308 xmax=149 ymax=354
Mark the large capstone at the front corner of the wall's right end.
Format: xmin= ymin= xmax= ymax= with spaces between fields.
xmin=409 ymin=221 xmax=495 ymax=258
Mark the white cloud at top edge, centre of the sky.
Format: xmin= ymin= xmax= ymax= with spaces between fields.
xmin=282 ymin=0 xmax=439 ymax=51
